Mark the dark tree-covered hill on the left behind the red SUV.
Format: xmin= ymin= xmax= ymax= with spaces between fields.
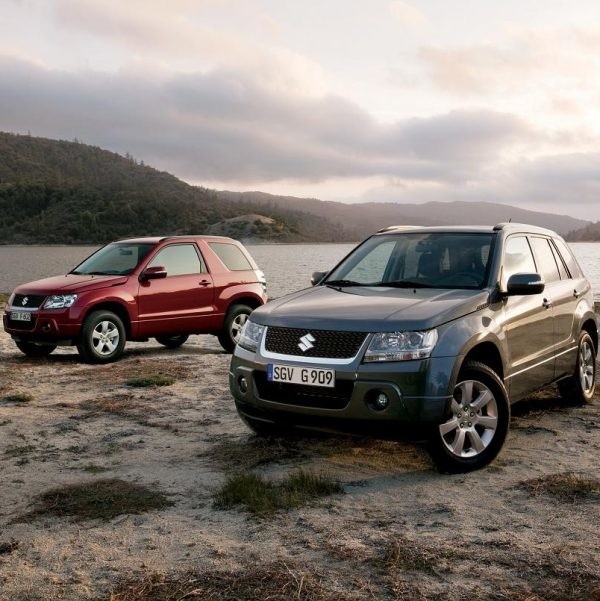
xmin=0 ymin=132 xmax=356 ymax=244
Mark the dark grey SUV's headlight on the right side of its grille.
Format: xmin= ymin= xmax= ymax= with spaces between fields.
xmin=364 ymin=330 xmax=437 ymax=363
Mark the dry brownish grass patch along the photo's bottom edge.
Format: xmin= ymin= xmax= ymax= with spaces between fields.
xmin=102 ymin=563 xmax=364 ymax=601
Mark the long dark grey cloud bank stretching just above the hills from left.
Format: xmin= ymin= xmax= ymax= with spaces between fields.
xmin=0 ymin=58 xmax=528 ymax=183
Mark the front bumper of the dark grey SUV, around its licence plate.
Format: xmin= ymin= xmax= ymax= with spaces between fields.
xmin=229 ymin=347 xmax=456 ymax=431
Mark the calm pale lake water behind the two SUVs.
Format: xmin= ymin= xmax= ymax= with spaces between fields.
xmin=0 ymin=242 xmax=600 ymax=300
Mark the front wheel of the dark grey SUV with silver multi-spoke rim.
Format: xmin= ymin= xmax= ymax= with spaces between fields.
xmin=430 ymin=361 xmax=510 ymax=473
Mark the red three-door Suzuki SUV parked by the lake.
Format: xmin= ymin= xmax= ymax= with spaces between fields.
xmin=3 ymin=236 xmax=267 ymax=363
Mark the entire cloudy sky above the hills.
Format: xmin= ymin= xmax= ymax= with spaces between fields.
xmin=0 ymin=0 xmax=600 ymax=221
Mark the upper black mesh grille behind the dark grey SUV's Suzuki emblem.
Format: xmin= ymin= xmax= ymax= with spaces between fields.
xmin=265 ymin=327 xmax=367 ymax=359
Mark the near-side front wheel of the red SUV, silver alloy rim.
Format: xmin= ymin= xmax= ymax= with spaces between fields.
xmin=77 ymin=311 xmax=125 ymax=363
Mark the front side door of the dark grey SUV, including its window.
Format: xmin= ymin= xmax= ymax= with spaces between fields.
xmin=503 ymin=235 xmax=555 ymax=398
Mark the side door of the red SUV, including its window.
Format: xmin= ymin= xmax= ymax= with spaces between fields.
xmin=138 ymin=243 xmax=215 ymax=337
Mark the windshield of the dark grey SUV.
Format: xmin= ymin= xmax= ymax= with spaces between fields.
xmin=324 ymin=232 xmax=493 ymax=289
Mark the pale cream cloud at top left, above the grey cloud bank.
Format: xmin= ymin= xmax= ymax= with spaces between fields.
xmin=53 ymin=0 xmax=326 ymax=95
